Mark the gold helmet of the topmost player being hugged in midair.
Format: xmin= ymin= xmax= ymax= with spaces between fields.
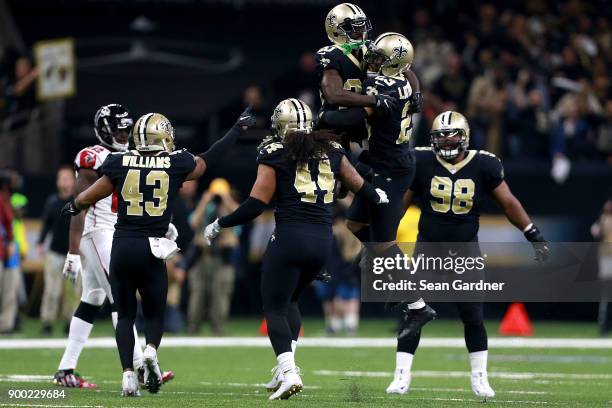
xmin=325 ymin=3 xmax=372 ymax=45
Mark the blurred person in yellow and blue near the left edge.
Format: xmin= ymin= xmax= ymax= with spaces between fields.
xmin=0 ymin=193 xmax=29 ymax=333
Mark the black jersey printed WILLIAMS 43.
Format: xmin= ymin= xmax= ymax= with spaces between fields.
xmin=101 ymin=149 xmax=195 ymax=237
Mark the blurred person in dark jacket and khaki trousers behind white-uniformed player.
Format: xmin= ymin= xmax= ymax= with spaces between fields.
xmin=38 ymin=166 xmax=81 ymax=336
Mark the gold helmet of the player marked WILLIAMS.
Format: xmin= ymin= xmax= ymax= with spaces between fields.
xmin=132 ymin=113 xmax=174 ymax=153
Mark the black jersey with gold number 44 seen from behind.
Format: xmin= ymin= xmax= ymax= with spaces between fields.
xmin=257 ymin=141 xmax=345 ymax=225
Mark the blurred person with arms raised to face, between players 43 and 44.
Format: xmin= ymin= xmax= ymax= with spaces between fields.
xmin=185 ymin=178 xmax=240 ymax=335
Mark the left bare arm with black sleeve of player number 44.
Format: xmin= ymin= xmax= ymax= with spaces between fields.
xmin=204 ymin=164 xmax=276 ymax=245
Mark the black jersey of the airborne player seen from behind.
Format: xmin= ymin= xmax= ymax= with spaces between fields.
xmin=363 ymin=75 xmax=414 ymax=175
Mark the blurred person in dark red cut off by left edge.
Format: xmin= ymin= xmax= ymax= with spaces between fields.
xmin=0 ymin=171 xmax=15 ymax=332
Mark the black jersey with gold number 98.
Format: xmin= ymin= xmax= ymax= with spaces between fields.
xmin=411 ymin=148 xmax=504 ymax=242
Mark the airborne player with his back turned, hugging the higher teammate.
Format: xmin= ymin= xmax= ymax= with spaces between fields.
xmin=322 ymin=33 xmax=436 ymax=333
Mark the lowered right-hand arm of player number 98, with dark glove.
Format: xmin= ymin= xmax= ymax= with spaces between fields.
xmin=491 ymin=181 xmax=549 ymax=261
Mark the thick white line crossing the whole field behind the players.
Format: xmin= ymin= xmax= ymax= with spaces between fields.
xmin=0 ymin=337 xmax=612 ymax=350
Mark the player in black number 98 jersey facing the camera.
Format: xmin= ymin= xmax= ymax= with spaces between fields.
xmin=387 ymin=111 xmax=548 ymax=398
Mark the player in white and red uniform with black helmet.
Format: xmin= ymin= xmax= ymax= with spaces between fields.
xmin=54 ymin=104 xmax=178 ymax=388
